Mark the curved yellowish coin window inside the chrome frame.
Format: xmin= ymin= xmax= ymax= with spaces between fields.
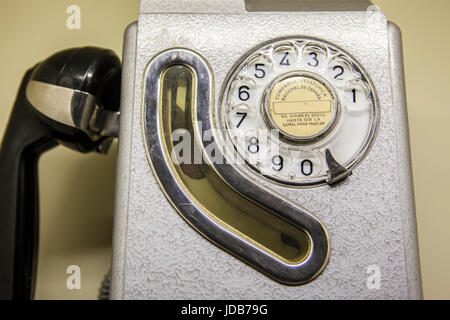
xmin=159 ymin=65 xmax=311 ymax=264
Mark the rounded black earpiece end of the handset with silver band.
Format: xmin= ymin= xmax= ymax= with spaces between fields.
xmin=26 ymin=47 xmax=121 ymax=153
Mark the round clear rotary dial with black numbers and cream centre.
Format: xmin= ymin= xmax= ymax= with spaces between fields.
xmin=218 ymin=38 xmax=379 ymax=186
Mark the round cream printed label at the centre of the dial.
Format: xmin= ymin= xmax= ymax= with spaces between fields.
xmin=269 ymin=76 xmax=336 ymax=138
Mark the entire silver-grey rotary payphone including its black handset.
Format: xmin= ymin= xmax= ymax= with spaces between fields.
xmin=0 ymin=0 xmax=421 ymax=299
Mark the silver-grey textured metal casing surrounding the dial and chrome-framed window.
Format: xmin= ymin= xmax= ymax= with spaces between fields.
xmin=112 ymin=1 xmax=422 ymax=299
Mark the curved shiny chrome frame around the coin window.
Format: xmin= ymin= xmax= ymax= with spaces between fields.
xmin=142 ymin=48 xmax=330 ymax=285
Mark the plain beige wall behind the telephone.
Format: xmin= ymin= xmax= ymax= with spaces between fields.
xmin=0 ymin=0 xmax=450 ymax=299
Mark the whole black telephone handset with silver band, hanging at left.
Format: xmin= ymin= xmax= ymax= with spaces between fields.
xmin=0 ymin=47 xmax=121 ymax=299
